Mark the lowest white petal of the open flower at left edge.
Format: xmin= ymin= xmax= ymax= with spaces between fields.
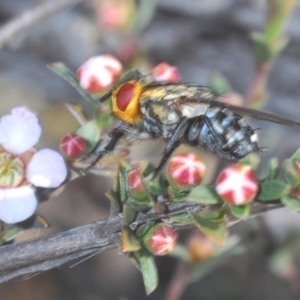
xmin=0 ymin=186 xmax=37 ymax=224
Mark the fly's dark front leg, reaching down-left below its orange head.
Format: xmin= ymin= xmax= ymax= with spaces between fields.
xmin=80 ymin=127 xmax=124 ymax=175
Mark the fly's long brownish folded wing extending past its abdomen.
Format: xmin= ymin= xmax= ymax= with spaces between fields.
xmin=146 ymin=82 xmax=300 ymax=126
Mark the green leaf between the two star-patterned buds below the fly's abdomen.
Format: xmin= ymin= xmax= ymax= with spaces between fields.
xmin=186 ymin=185 xmax=222 ymax=205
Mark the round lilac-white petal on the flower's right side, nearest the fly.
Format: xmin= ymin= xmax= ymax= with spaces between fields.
xmin=26 ymin=149 xmax=67 ymax=188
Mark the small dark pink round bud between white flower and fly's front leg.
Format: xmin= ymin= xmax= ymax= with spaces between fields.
xmin=59 ymin=134 xmax=86 ymax=158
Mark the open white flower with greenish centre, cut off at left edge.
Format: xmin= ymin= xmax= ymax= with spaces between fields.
xmin=0 ymin=107 xmax=67 ymax=223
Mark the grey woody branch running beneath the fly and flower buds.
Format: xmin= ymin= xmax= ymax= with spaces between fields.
xmin=0 ymin=202 xmax=282 ymax=282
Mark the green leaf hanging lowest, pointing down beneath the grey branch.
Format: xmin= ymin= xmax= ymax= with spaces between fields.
xmin=134 ymin=250 xmax=158 ymax=295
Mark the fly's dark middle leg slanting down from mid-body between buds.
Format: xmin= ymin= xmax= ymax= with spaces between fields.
xmin=153 ymin=118 xmax=189 ymax=178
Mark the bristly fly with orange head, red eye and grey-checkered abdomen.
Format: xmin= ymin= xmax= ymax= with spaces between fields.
xmin=83 ymin=70 xmax=300 ymax=174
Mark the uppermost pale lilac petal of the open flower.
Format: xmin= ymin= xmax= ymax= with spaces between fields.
xmin=0 ymin=107 xmax=42 ymax=154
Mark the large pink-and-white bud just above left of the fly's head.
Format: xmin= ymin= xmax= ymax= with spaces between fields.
xmin=77 ymin=55 xmax=122 ymax=93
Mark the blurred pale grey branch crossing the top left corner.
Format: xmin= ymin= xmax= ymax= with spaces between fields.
xmin=0 ymin=0 xmax=83 ymax=49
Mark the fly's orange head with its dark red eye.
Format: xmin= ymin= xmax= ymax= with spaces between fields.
xmin=112 ymin=80 xmax=144 ymax=124
